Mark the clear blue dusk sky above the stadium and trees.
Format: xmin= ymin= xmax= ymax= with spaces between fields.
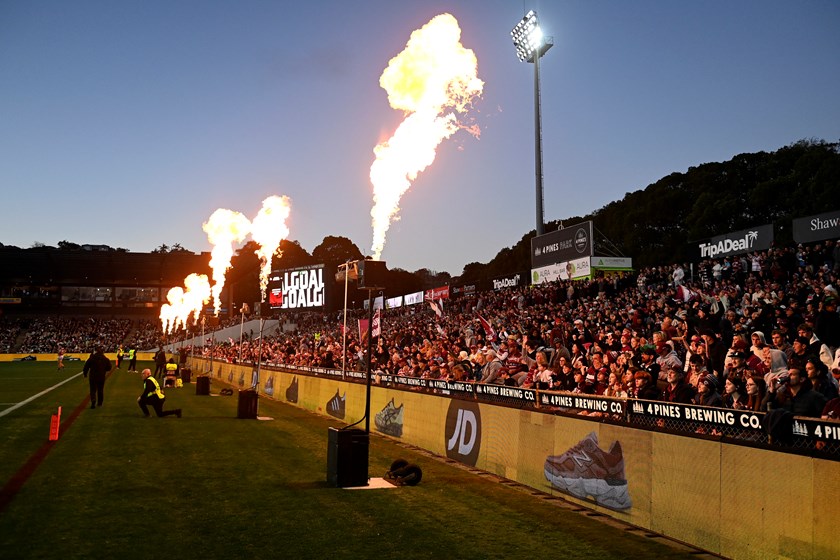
xmin=0 ymin=0 xmax=840 ymax=275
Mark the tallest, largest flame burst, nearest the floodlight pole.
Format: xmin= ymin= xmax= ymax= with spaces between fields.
xmin=370 ymin=14 xmax=484 ymax=259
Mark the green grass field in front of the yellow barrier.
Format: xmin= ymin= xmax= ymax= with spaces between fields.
xmin=0 ymin=362 xmax=698 ymax=560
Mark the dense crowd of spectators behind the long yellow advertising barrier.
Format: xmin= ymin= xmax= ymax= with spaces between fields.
xmin=197 ymin=241 xmax=840 ymax=417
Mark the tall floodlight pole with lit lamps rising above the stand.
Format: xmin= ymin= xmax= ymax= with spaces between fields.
xmin=510 ymin=10 xmax=554 ymax=235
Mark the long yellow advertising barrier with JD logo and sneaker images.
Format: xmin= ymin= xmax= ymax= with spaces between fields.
xmin=191 ymin=358 xmax=840 ymax=560
